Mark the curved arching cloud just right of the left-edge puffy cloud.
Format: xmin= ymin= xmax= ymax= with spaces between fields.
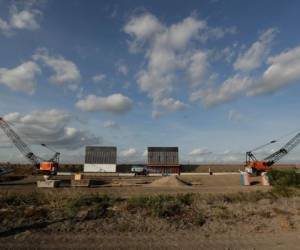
xmin=33 ymin=48 xmax=81 ymax=88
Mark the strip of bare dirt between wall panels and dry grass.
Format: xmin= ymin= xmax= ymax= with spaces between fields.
xmin=0 ymin=174 xmax=269 ymax=197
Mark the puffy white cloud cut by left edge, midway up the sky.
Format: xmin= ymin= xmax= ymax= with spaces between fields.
xmin=0 ymin=61 xmax=41 ymax=95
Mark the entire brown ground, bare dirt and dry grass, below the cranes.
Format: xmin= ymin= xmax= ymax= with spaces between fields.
xmin=0 ymin=171 xmax=300 ymax=249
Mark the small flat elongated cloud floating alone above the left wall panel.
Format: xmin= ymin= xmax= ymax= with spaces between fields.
xmin=76 ymin=94 xmax=132 ymax=113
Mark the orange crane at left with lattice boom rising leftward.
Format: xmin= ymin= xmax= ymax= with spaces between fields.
xmin=0 ymin=117 xmax=60 ymax=178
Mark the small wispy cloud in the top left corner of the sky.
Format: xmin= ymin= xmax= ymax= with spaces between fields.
xmin=0 ymin=4 xmax=42 ymax=35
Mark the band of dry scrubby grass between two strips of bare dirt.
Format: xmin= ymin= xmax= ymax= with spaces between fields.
xmin=0 ymin=189 xmax=300 ymax=237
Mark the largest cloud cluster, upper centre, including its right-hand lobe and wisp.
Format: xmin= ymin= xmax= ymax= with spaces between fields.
xmin=124 ymin=13 xmax=234 ymax=112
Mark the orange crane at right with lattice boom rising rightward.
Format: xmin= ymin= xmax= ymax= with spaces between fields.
xmin=245 ymin=133 xmax=300 ymax=176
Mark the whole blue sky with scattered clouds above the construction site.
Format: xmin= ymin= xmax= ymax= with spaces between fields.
xmin=0 ymin=0 xmax=300 ymax=163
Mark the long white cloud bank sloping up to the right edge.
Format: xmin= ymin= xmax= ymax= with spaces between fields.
xmin=195 ymin=42 xmax=300 ymax=106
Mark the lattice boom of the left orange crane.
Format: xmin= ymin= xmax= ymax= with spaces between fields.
xmin=0 ymin=117 xmax=40 ymax=166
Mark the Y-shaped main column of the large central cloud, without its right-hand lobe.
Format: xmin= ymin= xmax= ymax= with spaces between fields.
xmin=124 ymin=14 xmax=205 ymax=106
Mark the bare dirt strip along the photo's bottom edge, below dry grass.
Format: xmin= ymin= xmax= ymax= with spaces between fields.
xmin=0 ymin=231 xmax=300 ymax=250
